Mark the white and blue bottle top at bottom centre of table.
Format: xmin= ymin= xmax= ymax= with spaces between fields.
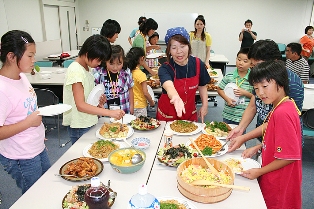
xmin=128 ymin=184 xmax=160 ymax=209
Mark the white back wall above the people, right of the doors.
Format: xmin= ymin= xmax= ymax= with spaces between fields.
xmin=77 ymin=0 xmax=313 ymax=65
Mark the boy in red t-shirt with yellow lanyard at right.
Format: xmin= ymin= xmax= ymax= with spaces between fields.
xmin=242 ymin=61 xmax=302 ymax=208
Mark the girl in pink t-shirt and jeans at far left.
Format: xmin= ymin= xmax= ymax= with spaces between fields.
xmin=0 ymin=30 xmax=50 ymax=194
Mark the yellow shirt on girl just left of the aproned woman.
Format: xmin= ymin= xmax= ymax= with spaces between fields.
xmin=132 ymin=68 xmax=147 ymax=108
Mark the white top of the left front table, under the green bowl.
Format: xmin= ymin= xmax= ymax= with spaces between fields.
xmin=11 ymin=118 xmax=166 ymax=209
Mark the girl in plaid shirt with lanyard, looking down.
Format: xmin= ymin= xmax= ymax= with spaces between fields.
xmin=94 ymin=45 xmax=134 ymax=114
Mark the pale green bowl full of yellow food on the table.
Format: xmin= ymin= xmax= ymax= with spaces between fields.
xmin=108 ymin=147 xmax=146 ymax=174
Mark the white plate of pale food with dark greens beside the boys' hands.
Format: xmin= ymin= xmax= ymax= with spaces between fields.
xmin=202 ymin=121 xmax=236 ymax=139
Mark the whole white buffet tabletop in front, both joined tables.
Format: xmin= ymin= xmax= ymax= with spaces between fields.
xmin=11 ymin=118 xmax=266 ymax=209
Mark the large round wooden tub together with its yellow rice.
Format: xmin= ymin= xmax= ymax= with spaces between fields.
xmin=177 ymin=157 xmax=235 ymax=203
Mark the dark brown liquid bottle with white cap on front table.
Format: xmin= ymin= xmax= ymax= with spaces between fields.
xmin=85 ymin=177 xmax=110 ymax=209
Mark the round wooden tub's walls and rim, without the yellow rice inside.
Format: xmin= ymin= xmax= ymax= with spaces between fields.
xmin=177 ymin=158 xmax=234 ymax=203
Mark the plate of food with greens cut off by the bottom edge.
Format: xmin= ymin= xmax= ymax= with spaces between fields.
xmin=157 ymin=196 xmax=197 ymax=209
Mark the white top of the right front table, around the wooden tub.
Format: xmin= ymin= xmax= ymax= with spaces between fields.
xmin=147 ymin=131 xmax=266 ymax=209
